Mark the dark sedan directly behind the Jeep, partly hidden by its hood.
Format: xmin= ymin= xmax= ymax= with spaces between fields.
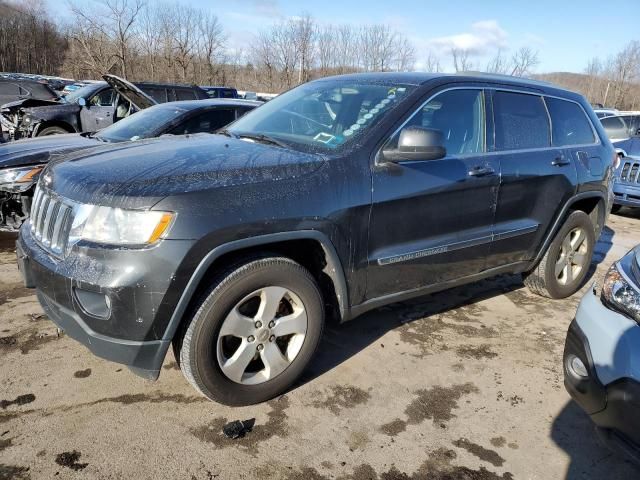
xmin=0 ymin=95 xmax=262 ymax=231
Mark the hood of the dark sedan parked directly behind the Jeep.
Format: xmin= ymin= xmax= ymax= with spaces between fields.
xmin=0 ymin=133 xmax=102 ymax=169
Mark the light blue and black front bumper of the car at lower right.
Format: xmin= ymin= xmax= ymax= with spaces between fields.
xmin=563 ymin=292 xmax=640 ymax=452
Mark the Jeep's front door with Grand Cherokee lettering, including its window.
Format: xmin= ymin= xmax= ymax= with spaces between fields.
xmin=367 ymin=88 xmax=500 ymax=299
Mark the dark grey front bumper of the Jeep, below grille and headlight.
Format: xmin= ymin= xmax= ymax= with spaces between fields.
xmin=16 ymin=222 xmax=193 ymax=379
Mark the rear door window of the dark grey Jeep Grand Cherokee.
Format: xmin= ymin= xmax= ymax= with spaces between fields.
xmin=493 ymin=91 xmax=551 ymax=150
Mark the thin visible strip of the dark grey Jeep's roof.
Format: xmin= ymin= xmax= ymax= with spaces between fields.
xmin=317 ymin=72 xmax=575 ymax=93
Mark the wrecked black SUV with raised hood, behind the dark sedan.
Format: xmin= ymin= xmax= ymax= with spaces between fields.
xmin=0 ymin=75 xmax=209 ymax=140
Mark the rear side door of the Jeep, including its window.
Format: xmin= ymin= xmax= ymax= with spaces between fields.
xmin=487 ymin=90 xmax=577 ymax=267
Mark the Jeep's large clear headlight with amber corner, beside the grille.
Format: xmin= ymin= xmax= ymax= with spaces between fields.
xmin=68 ymin=204 xmax=175 ymax=247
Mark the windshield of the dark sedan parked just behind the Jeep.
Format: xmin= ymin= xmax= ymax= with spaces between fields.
xmin=96 ymin=105 xmax=187 ymax=142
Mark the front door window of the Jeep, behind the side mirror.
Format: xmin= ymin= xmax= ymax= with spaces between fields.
xmin=385 ymin=89 xmax=485 ymax=155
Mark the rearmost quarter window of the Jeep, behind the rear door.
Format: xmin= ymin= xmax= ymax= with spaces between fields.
xmin=545 ymin=97 xmax=596 ymax=147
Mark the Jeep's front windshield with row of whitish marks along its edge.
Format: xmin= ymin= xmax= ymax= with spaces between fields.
xmin=228 ymin=80 xmax=415 ymax=151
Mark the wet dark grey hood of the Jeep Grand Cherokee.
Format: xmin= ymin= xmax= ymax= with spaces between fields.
xmin=43 ymin=134 xmax=324 ymax=208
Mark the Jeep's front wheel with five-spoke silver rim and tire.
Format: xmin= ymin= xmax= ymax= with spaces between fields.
xmin=174 ymin=257 xmax=324 ymax=406
